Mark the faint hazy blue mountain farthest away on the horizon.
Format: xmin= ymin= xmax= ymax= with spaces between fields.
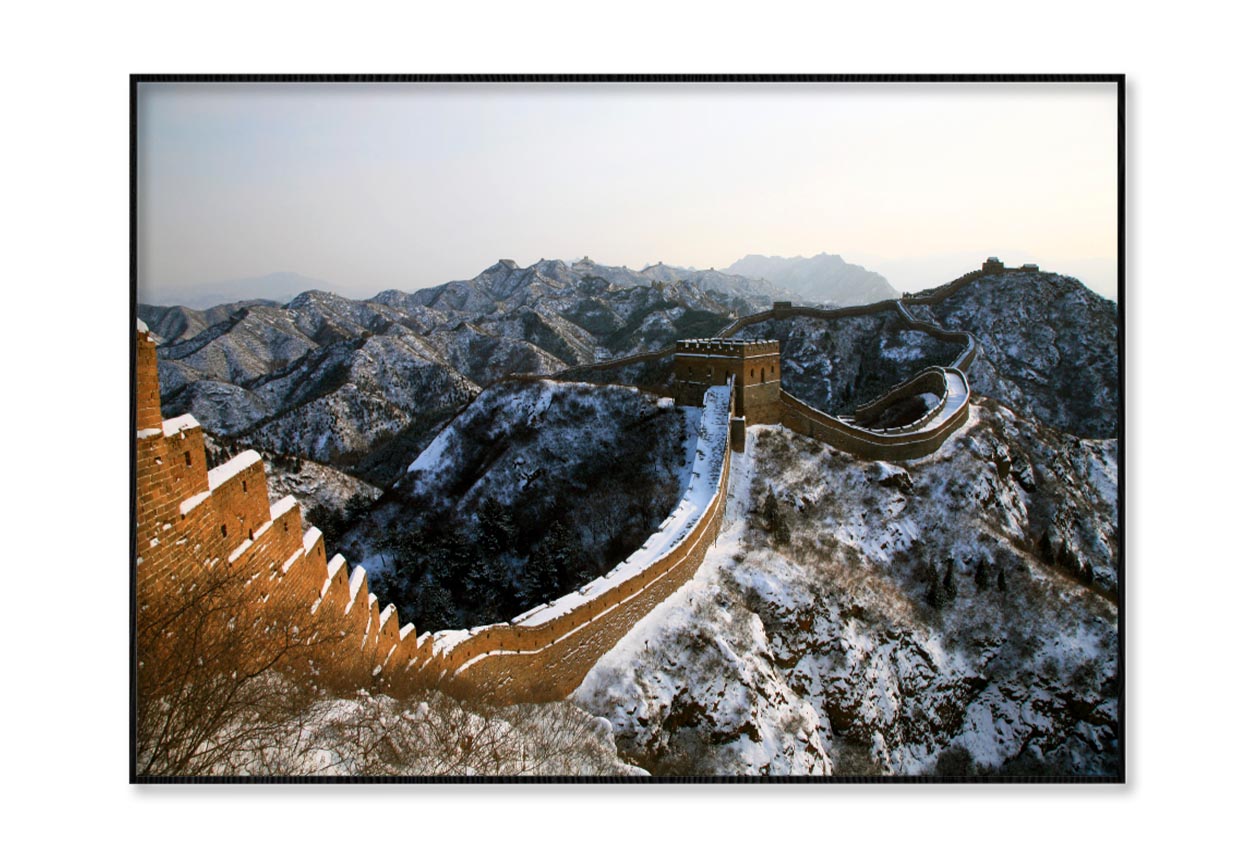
xmin=723 ymin=252 xmax=900 ymax=306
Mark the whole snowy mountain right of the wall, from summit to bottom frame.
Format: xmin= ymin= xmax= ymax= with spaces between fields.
xmin=563 ymin=271 xmax=1123 ymax=775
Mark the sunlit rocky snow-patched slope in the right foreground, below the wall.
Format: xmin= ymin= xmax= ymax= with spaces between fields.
xmin=574 ymin=405 xmax=1120 ymax=774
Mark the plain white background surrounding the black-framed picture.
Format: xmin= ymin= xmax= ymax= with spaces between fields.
xmin=0 ymin=0 xmax=1250 ymax=850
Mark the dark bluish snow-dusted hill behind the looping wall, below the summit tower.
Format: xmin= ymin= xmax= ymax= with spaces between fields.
xmin=737 ymin=271 xmax=1119 ymax=438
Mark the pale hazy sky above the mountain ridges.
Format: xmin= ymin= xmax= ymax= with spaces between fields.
xmin=138 ymin=84 xmax=1118 ymax=304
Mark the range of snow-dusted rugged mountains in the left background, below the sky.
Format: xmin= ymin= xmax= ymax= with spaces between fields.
xmin=139 ymin=259 xmax=781 ymax=486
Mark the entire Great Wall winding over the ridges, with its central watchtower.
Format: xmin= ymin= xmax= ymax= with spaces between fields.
xmin=134 ymin=264 xmax=1004 ymax=703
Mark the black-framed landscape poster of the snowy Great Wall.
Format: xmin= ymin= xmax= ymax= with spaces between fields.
xmin=129 ymin=75 xmax=1125 ymax=782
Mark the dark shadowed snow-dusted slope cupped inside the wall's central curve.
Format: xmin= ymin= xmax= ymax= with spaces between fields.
xmin=343 ymin=380 xmax=700 ymax=630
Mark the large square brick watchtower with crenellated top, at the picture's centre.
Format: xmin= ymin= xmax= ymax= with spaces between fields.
xmin=674 ymin=338 xmax=782 ymax=426
